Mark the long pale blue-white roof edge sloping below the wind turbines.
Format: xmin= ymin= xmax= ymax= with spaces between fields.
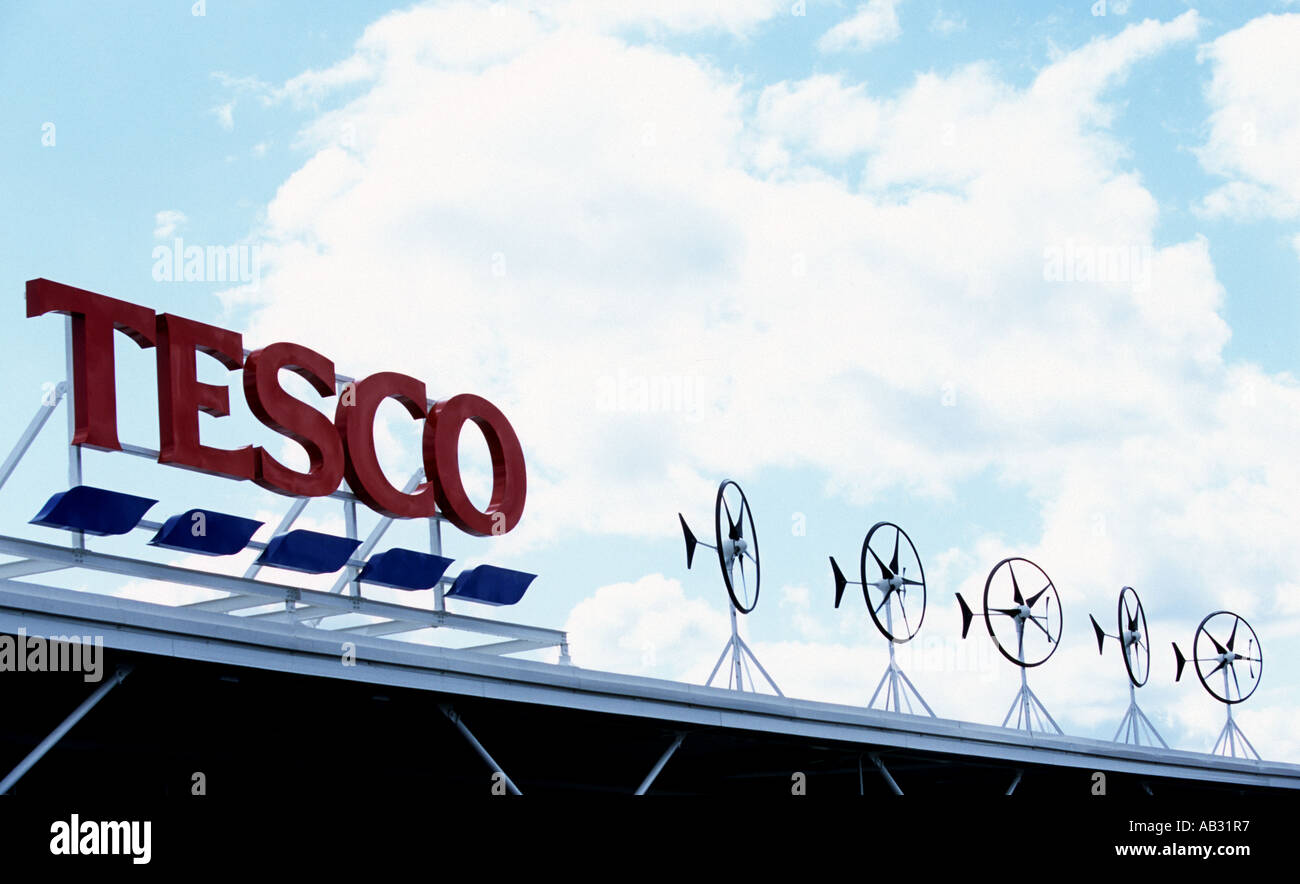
xmin=0 ymin=580 xmax=1300 ymax=789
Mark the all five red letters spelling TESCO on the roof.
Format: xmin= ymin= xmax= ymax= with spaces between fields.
xmin=27 ymin=280 xmax=528 ymax=536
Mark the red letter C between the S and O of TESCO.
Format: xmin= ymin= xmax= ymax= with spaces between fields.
xmin=334 ymin=372 xmax=437 ymax=519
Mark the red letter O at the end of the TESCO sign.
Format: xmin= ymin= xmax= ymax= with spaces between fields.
xmin=424 ymin=393 xmax=528 ymax=536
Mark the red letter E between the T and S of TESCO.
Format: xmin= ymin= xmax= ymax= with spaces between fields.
xmin=157 ymin=313 xmax=256 ymax=478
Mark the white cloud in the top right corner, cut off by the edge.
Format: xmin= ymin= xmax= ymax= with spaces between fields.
xmin=1199 ymin=14 xmax=1300 ymax=220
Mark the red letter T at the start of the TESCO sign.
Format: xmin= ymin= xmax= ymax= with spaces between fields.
xmin=27 ymin=280 xmax=155 ymax=451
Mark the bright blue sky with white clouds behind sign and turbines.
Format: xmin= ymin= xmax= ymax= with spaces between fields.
xmin=0 ymin=0 xmax=1300 ymax=762
